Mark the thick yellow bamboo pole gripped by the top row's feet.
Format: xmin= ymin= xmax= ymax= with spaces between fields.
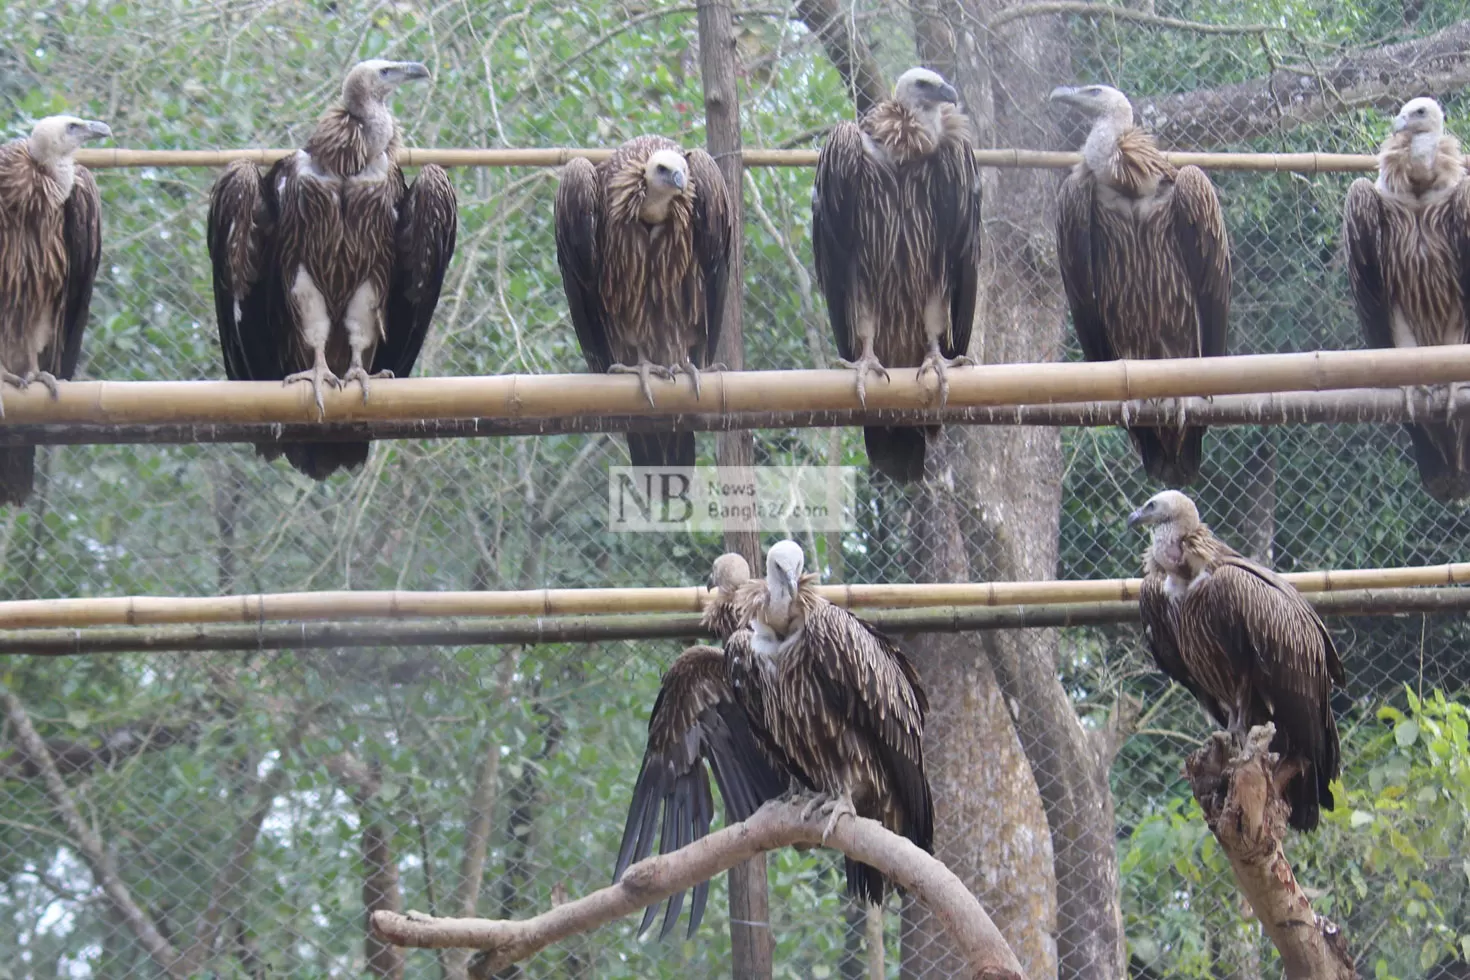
xmin=0 ymin=351 xmax=1470 ymax=425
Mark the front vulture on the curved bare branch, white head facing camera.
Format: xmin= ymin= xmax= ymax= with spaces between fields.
xmin=725 ymin=541 xmax=933 ymax=904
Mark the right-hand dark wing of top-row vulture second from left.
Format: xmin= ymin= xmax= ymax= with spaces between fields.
xmin=372 ymin=163 xmax=459 ymax=378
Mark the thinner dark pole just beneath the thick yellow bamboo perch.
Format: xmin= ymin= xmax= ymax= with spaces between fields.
xmin=0 ymin=385 xmax=1470 ymax=447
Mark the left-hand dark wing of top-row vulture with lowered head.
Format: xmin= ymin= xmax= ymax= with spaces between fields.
xmin=554 ymin=159 xmax=613 ymax=373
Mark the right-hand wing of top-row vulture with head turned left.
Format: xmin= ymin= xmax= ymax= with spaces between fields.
xmin=1172 ymin=166 xmax=1230 ymax=357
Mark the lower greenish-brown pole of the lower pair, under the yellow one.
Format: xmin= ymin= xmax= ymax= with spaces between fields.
xmin=0 ymin=588 xmax=1470 ymax=657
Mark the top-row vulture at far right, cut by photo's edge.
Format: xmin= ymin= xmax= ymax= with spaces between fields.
xmin=1342 ymin=98 xmax=1470 ymax=502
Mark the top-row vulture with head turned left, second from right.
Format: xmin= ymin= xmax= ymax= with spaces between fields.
xmin=1051 ymin=85 xmax=1230 ymax=486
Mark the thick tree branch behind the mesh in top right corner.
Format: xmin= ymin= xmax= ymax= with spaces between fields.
xmin=1133 ymin=21 xmax=1470 ymax=147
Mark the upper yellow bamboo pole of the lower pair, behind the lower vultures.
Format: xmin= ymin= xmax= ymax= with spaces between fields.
xmin=0 ymin=563 xmax=1470 ymax=629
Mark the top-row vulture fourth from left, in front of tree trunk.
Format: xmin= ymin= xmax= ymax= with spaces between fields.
xmin=811 ymin=68 xmax=980 ymax=483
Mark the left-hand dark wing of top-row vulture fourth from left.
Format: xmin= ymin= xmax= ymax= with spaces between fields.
xmin=811 ymin=122 xmax=873 ymax=360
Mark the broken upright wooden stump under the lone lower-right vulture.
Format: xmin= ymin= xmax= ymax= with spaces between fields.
xmin=1185 ymin=723 xmax=1357 ymax=980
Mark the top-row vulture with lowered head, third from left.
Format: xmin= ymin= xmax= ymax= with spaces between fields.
xmin=556 ymin=137 xmax=735 ymax=467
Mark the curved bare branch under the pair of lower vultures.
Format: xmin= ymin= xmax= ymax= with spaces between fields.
xmin=372 ymin=802 xmax=1023 ymax=980
